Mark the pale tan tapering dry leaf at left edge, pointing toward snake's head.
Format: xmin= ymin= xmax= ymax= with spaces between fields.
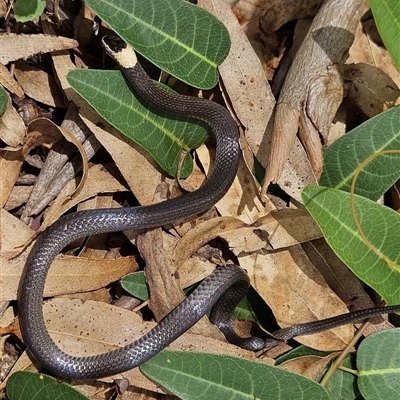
xmin=0 ymin=33 xmax=79 ymax=65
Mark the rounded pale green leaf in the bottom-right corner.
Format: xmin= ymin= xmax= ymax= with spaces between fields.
xmin=357 ymin=328 xmax=400 ymax=400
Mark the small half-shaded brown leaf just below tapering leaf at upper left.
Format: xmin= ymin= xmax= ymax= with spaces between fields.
xmin=15 ymin=60 xmax=65 ymax=108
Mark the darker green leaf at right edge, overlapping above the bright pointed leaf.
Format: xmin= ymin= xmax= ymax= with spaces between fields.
xmin=319 ymin=106 xmax=400 ymax=200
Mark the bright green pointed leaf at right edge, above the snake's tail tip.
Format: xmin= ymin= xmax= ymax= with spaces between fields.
xmin=302 ymin=186 xmax=400 ymax=304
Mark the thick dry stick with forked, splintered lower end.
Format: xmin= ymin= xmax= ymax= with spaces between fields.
xmin=262 ymin=0 xmax=366 ymax=194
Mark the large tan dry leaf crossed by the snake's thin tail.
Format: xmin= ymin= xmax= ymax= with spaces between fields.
xmin=239 ymin=246 xmax=353 ymax=351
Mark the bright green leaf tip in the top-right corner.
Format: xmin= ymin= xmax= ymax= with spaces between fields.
xmin=369 ymin=0 xmax=400 ymax=70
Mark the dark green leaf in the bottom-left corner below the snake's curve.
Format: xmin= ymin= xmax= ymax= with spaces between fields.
xmin=6 ymin=372 xmax=89 ymax=400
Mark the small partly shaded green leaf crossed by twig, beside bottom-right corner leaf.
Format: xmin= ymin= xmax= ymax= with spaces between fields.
xmin=326 ymin=354 xmax=363 ymax=400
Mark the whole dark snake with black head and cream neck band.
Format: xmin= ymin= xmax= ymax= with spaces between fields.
xmin=18 ymin=36 xmax=400 ymax=380
